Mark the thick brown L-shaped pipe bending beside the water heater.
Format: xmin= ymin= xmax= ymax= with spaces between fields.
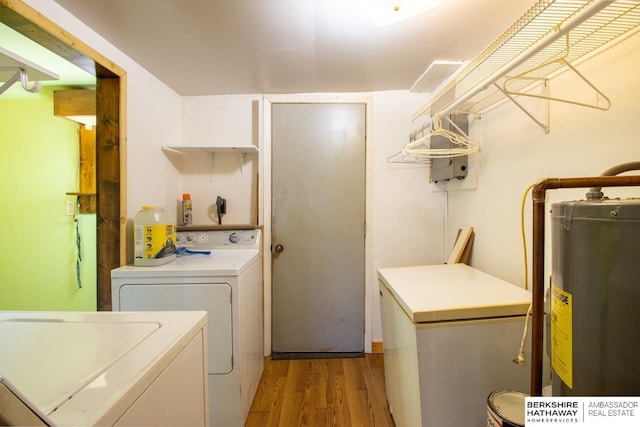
xmin=531 ymin=175 xmax=640 ymax=396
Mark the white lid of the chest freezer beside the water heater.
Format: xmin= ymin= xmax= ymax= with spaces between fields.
xmin=378 ymin=264 xmax=531 ymax=323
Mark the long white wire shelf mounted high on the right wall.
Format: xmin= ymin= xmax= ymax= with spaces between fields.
xmin=412 ymin=0 xmax=640 ymax=123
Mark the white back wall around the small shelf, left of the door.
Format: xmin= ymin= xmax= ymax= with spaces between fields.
xmin=180 ymin=95 xmax=262 ymax=224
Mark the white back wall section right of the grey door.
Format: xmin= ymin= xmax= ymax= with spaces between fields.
xmin=368 ymin=91 xmax=450 ymax=341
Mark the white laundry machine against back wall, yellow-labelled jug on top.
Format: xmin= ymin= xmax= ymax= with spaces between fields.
xmin=111 ymin=227 xmax=264 ymax=427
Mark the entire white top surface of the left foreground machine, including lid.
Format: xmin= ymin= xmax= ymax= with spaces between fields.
xmin=0 ymin=312 xmax=206 ymax=425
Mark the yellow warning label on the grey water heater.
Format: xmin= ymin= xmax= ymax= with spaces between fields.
xmin=551 ymin=285 xmax=573 ymax=388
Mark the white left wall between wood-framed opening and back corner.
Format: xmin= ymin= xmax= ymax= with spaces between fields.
xmin=25 ymin=0 xmax=182 ymax=262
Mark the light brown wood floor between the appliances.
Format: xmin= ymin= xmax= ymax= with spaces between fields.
xmin=246 ymin=354 xmax=394 ymax=427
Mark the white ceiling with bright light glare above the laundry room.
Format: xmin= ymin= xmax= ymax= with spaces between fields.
xmin=50 ymin=0 xmax=534 ymax=96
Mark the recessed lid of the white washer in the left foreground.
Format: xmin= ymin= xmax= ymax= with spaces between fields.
xmin=0 ymin=319 xmax=159 ymax=415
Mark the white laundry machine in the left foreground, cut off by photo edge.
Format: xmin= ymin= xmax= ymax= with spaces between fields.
xmin=0 ymin=311 xmax=208 ymax=427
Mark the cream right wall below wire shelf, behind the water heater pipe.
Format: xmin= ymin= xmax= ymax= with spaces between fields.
xmin=447 ymin=34 xmax=640 ymax=286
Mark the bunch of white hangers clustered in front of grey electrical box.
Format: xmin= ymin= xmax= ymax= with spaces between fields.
xmin=402 ymin=114 xmax=480 ymax=159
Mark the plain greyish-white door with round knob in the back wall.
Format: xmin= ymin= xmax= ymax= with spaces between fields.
xmin=272 ymin=103 xmax=366 ymax=357
